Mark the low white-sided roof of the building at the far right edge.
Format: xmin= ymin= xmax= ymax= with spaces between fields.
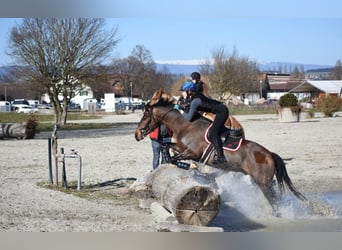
xmin=289 ymin=81 xmax=342 ymax=94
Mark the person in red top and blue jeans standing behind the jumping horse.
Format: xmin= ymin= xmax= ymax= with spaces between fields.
xmin=149 ymin=124 xmax=171 ymax=169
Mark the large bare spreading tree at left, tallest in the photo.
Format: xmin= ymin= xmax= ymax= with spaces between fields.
xmin=9 ymin=18 xmax=118 ymax=124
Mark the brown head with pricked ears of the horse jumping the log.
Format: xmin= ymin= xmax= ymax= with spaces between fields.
xmin=135 ymin=89 xmax=175 ymax=141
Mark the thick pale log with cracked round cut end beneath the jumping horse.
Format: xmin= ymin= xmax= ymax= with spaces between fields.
xmin=131 ymin=164 xmax=220 ymax=226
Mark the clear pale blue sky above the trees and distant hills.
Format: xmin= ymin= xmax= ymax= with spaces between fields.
xmin=0 ymin=0 xmax=342 ymax=66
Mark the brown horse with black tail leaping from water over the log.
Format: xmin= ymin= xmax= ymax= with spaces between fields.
xmin=135 ymin=90 xmax=306 ymax=205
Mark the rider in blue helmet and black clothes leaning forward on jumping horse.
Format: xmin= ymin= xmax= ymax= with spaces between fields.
xmin=183 ymin=82 xmax=229 ymax=168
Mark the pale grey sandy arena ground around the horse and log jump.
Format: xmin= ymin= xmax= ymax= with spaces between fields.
xmin=0 ymin=111 xmax=342 ymax=232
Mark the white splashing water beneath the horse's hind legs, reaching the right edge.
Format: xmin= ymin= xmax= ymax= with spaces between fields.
xmin=210 ymin=169 xmax=342 ymax=219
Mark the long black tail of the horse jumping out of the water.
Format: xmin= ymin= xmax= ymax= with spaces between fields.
xmin=272 ymin=152 xmax=307 ymax=201
